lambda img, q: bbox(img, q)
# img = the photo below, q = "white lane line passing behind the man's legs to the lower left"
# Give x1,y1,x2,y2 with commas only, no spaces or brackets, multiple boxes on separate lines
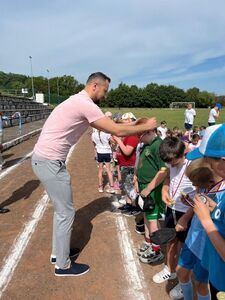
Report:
0,146,75,298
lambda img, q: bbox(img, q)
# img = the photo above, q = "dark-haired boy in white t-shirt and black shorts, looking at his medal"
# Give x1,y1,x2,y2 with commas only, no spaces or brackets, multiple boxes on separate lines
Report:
153,137,195,283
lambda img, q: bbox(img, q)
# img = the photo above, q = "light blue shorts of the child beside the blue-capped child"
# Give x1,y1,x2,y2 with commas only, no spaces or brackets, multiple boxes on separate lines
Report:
178,243,209,283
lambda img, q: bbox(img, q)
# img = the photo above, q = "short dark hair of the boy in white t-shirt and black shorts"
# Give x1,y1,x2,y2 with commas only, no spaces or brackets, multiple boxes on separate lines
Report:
159,137,185,163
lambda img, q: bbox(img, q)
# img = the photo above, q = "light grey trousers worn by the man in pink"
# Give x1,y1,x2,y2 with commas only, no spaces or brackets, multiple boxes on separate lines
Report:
32,154,75,269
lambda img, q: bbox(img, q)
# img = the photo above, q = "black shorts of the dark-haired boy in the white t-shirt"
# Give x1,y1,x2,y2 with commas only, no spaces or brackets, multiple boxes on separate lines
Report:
165,207,191,243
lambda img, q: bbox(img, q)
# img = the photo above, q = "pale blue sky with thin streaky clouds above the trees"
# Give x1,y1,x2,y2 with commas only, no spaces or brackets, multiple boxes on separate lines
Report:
0,0,225,95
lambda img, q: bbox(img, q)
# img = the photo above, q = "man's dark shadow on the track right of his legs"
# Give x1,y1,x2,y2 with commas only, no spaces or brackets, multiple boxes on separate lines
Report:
71,197,111,250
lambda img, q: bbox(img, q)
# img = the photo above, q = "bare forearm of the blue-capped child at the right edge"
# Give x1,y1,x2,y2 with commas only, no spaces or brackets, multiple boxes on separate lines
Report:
194,196,225,262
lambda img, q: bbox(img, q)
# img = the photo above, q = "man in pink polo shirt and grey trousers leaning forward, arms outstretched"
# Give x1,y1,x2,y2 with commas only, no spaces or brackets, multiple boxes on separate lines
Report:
32,72,156,276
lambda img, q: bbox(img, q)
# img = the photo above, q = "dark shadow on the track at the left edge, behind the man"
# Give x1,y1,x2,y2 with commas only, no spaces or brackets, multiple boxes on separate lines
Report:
0,180,40,207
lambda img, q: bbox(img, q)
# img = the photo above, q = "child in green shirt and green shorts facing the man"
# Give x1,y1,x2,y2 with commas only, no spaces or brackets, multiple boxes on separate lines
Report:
135,123,167,263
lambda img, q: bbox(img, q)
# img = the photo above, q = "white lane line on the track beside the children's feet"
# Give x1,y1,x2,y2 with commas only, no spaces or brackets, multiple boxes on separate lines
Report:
115,216,151,300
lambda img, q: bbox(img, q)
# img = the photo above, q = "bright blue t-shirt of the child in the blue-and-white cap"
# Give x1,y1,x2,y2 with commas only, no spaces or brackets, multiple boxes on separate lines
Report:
201,192,225,292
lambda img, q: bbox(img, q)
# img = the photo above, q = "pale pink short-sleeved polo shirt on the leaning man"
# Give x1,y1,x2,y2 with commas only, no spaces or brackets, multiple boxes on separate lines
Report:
34,90,105,160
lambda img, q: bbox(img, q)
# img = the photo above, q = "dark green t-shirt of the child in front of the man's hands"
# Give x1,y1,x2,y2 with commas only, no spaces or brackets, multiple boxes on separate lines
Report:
136,137,165,184
